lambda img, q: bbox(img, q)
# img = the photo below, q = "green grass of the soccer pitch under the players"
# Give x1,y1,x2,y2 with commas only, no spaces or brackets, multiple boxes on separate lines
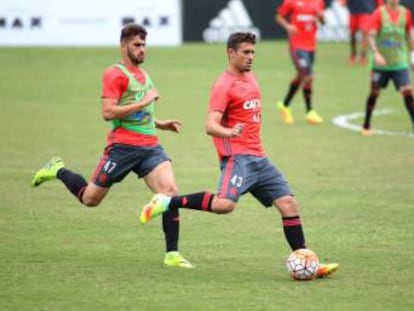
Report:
0,42,414,311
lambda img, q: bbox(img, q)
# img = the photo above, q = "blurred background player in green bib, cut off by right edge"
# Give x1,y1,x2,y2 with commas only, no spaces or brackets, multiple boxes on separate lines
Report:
362,0,414,136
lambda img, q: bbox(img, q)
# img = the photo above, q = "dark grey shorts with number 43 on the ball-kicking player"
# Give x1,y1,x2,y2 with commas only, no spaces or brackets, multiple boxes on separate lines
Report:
217,155,292,207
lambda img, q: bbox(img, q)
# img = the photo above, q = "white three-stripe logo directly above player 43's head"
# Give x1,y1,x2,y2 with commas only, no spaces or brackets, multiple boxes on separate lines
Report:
203,0,260,42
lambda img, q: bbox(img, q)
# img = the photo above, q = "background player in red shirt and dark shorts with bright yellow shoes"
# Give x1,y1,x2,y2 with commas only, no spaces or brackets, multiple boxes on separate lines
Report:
276,0,324,124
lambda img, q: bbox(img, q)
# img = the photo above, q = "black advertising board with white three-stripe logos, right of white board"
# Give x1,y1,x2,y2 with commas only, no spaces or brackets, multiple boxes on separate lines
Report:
183,0,414,42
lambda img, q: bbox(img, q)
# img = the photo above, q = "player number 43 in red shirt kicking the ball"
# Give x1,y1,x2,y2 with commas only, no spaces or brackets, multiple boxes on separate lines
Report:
140,32,338,277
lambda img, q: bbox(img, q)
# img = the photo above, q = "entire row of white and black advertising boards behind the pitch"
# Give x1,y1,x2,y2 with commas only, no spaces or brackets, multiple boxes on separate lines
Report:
0,0,414,46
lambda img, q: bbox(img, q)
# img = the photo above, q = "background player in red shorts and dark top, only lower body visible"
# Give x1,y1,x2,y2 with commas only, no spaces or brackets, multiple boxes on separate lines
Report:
340,0,383,64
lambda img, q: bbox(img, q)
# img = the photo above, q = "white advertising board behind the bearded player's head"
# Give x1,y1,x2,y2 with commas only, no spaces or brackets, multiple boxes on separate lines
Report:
0,0,182,46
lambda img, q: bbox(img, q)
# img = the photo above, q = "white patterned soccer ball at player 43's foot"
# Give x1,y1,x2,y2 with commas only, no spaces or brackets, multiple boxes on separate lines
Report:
286,248,319,280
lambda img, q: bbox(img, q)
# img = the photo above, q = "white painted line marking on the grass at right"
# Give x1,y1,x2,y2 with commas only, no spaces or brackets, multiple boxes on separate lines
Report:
332,109,414,138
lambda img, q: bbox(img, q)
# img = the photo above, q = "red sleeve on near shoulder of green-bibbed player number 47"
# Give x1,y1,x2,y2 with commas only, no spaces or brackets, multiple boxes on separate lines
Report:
102,67,128,98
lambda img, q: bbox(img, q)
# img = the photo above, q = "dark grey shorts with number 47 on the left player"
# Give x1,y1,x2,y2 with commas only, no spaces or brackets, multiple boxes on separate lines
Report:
91,144,170,188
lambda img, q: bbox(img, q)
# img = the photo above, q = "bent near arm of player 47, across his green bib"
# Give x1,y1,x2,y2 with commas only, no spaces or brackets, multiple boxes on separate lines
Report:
102,89,160,121
